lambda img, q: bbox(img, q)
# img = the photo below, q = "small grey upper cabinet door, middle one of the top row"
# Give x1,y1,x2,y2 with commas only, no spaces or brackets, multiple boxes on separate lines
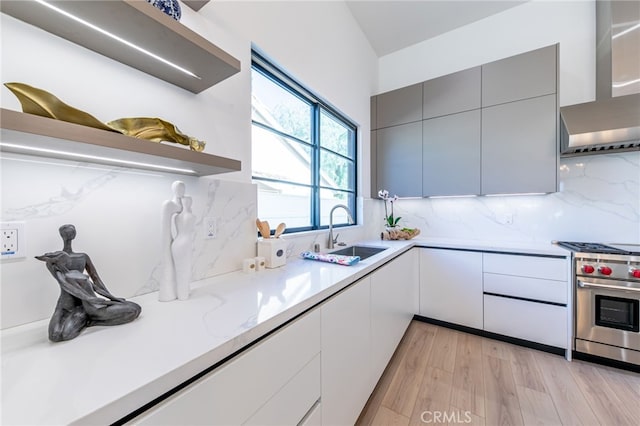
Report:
422,67,481,118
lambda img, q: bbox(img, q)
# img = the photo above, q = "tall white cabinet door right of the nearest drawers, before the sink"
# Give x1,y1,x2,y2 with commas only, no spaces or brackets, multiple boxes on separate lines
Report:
321,277,372,425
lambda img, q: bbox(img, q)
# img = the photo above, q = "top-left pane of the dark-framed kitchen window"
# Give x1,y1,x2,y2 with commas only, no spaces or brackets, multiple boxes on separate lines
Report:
251,70,312,142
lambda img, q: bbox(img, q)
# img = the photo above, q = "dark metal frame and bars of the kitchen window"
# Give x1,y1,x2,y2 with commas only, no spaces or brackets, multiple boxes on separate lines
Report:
251,49,358,233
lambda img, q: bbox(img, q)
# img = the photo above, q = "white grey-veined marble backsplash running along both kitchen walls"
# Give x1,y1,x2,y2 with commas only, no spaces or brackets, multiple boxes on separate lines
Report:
0,152,640,329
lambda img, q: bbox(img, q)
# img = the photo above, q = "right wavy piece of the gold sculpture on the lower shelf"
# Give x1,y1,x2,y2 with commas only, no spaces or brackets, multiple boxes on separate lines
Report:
107,117,205,152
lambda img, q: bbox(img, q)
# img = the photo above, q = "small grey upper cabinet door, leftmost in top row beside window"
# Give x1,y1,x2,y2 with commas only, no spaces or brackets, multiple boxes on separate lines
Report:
376,83,422,129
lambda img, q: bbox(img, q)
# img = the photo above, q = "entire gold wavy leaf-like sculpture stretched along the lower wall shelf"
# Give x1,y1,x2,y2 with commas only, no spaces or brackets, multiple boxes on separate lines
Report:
4,83,206,152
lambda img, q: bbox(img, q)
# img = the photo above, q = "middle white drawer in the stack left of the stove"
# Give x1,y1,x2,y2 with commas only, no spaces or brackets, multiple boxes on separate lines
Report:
483,272,567,305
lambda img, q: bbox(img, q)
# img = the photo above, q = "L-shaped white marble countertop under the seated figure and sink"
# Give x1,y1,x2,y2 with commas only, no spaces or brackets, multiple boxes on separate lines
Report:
1,239,568,425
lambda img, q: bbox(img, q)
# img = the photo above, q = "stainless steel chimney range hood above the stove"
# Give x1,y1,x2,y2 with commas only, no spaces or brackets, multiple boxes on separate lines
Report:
560,1,640,156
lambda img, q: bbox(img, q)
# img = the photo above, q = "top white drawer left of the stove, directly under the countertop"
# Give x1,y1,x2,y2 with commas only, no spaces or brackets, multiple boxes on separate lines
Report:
482,253,568,281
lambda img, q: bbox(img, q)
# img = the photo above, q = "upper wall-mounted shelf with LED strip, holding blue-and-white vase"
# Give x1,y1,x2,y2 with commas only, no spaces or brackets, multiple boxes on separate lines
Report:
0,0,240,93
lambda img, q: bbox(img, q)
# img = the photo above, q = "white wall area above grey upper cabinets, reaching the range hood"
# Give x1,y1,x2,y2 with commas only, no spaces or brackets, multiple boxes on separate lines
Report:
377,0,595,106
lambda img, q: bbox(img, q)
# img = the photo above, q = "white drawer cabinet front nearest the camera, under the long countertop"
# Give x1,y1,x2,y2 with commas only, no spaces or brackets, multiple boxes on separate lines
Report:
131,310,320,425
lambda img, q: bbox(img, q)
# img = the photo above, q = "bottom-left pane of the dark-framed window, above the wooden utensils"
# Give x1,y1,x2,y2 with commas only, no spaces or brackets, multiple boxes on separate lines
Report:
254,180,311,228
